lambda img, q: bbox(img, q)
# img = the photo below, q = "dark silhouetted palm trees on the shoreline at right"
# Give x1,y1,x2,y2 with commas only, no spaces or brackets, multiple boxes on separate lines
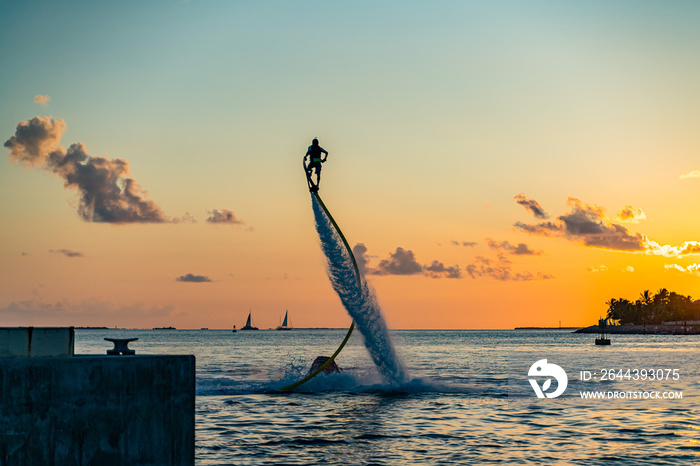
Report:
605,288,700,325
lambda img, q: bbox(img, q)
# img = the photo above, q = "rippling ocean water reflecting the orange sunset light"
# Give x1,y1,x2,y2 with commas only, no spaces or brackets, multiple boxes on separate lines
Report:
76,330,700,465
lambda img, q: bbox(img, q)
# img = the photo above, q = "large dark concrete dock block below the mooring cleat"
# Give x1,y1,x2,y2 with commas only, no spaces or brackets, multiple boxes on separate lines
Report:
0,355,195,466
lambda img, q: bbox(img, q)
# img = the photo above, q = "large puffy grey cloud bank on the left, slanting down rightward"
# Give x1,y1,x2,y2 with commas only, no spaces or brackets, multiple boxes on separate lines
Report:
5,117,169,223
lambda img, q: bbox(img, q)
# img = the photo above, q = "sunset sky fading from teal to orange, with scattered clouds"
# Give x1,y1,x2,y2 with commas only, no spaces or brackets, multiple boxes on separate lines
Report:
0,0,700,329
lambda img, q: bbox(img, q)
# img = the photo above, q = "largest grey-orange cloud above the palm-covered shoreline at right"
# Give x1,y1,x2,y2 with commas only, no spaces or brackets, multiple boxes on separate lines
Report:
514,197,646,251
